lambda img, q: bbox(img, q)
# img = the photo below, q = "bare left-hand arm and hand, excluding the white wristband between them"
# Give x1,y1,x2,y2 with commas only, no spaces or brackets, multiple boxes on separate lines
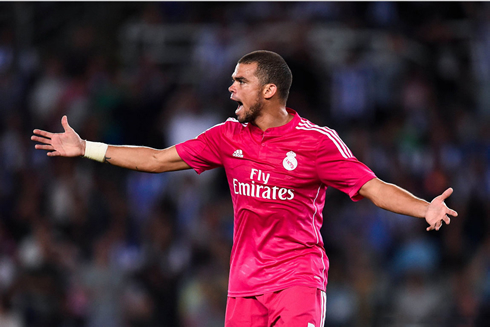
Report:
31,116,191,173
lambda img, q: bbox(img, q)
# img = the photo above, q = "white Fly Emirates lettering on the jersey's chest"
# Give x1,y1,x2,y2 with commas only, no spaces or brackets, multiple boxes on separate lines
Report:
233,168,294,201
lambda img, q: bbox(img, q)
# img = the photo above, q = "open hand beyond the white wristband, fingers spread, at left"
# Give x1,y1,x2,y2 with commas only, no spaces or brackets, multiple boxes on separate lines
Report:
31,115,85,157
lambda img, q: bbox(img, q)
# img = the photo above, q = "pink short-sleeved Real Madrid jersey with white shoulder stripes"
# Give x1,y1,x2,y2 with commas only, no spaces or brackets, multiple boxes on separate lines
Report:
176,109,376,297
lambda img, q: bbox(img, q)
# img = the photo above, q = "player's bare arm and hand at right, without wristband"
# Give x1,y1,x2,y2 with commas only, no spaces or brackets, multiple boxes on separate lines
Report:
359,178,458,231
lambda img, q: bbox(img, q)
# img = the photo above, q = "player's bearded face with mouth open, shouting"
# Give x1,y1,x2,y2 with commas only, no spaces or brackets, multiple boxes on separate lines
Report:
228,63,264,123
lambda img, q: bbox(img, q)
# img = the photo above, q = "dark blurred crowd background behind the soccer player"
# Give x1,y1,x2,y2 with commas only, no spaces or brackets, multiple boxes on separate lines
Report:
0,2,490,327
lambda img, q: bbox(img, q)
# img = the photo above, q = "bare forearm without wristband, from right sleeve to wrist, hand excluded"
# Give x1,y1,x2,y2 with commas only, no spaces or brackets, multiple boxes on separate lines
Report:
360,179,429,218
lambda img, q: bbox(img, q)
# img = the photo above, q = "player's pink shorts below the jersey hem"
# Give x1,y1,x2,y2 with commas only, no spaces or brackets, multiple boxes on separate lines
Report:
225,286,327,327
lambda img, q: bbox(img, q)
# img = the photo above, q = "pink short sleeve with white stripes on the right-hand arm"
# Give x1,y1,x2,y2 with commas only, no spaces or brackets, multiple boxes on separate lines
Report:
316,132,376,201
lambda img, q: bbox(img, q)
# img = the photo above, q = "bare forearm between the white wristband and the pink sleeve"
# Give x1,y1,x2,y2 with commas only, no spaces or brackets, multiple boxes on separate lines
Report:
82,145,190,173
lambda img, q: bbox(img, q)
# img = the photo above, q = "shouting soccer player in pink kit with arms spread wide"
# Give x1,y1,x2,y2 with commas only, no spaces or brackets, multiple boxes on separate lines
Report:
32,50,457,327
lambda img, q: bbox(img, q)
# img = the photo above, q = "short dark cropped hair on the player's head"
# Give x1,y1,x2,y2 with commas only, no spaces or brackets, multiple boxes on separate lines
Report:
238,50,293,102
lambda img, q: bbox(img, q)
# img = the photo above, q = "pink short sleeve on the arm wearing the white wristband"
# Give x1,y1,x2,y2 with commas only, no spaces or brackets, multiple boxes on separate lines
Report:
175,123,224,174
